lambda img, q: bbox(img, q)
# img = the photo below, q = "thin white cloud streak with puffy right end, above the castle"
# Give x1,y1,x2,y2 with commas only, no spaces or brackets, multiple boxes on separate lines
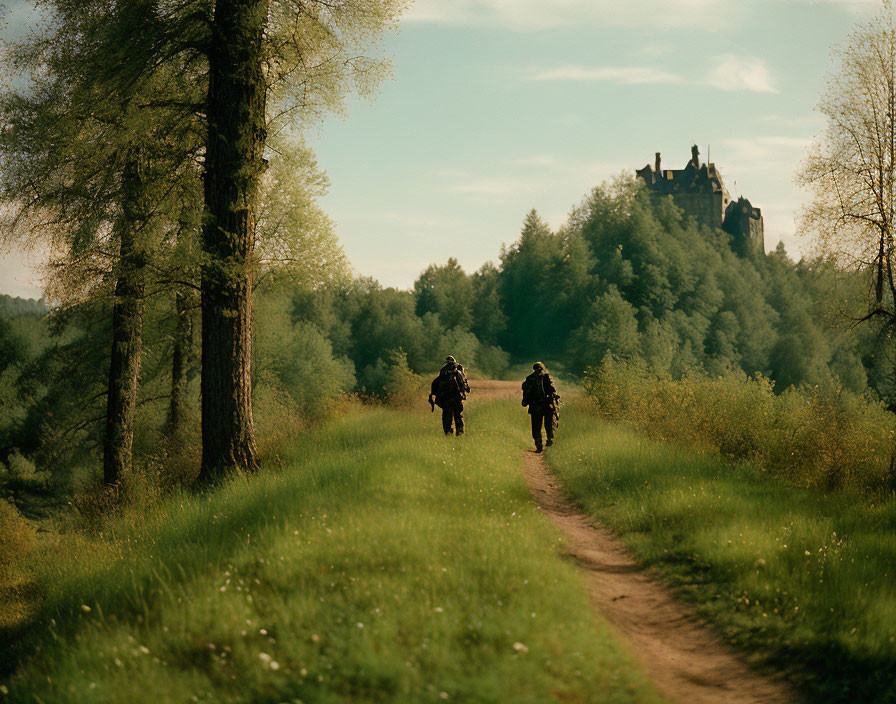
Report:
525,54,779,93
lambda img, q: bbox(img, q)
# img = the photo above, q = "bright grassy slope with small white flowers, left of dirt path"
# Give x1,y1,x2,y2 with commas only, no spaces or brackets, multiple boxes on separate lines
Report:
0,403,657,704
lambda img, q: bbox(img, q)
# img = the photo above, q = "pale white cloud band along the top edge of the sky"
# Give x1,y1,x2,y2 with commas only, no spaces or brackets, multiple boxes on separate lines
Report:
405,0,744,31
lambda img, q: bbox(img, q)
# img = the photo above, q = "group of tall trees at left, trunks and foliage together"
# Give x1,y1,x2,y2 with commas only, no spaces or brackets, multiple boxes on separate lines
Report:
0,0,407,493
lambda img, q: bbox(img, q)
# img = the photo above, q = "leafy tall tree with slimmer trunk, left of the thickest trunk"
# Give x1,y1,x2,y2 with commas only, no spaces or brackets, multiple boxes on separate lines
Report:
0,0,206,484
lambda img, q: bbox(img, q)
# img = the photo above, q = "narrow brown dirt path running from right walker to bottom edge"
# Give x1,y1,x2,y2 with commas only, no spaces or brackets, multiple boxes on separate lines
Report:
524,451,798,704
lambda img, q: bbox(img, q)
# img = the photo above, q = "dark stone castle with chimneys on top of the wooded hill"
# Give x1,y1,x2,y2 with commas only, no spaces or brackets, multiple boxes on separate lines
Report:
636,145,765,255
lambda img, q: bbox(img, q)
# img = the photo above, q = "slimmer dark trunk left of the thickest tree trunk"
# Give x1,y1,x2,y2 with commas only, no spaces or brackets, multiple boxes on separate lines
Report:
103,160,146,485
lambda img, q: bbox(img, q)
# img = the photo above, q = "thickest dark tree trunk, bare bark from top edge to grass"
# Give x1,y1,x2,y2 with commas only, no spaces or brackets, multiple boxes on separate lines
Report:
199,0,268,482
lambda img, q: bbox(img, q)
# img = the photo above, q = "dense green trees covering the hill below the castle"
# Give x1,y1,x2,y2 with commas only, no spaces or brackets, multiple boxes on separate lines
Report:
398,178,876,398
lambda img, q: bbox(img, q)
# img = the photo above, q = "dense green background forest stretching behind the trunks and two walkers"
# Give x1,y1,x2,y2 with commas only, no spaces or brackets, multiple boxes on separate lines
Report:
0,172,893,494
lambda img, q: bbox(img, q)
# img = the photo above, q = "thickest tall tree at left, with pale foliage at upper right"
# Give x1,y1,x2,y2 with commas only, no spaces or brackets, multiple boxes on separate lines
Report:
200,0,407,482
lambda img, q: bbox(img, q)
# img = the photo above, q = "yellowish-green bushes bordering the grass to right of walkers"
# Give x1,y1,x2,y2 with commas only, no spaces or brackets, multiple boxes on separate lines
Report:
584,355,896,491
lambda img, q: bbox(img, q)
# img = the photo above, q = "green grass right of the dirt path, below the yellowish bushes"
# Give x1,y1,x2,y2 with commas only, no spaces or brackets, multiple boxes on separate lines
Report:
548,404,896,704
